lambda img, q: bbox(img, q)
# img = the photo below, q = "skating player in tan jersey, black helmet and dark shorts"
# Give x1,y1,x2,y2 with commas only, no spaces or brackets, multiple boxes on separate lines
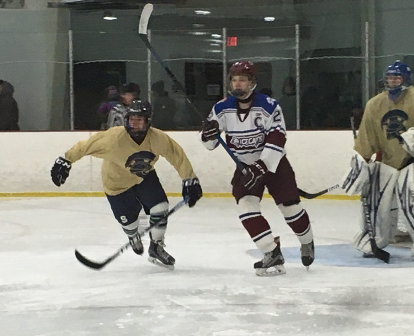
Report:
51,100,202,269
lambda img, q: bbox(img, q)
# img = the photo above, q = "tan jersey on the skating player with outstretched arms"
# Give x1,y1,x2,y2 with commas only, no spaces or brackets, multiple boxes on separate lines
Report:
65,126,195,195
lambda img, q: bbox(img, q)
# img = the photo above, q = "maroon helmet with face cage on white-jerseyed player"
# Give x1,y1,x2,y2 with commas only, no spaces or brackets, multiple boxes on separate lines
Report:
227,61,257,99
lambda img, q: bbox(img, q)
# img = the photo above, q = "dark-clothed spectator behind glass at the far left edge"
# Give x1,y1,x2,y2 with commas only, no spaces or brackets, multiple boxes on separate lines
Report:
0,79,20,131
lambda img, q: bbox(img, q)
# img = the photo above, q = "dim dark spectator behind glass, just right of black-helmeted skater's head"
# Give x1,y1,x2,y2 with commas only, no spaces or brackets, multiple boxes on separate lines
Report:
151,80,177,130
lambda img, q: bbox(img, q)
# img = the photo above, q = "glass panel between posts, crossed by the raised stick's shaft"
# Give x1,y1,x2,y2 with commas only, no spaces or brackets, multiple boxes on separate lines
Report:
151,27,223,130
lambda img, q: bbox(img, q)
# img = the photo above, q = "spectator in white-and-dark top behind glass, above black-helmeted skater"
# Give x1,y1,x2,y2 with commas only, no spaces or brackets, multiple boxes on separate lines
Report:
107,83,141,128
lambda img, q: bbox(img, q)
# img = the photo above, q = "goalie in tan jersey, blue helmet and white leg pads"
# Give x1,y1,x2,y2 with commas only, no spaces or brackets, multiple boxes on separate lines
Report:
343,61,414,256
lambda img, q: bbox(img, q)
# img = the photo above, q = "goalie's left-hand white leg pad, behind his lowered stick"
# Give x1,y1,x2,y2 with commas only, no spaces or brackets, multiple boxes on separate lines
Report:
353,162,399,253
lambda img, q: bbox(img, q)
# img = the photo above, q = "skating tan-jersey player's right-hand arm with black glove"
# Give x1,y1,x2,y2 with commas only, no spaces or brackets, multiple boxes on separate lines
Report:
157,131,203,208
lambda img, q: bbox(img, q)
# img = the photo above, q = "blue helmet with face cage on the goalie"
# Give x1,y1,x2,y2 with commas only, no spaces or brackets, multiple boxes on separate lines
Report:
384,61,411,100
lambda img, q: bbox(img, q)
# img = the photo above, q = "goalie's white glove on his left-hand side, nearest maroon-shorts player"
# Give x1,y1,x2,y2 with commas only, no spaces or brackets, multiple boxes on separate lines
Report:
342,151,369,196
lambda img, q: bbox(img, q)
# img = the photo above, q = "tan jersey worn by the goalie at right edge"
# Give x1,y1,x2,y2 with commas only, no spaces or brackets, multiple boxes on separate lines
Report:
354,86,414,169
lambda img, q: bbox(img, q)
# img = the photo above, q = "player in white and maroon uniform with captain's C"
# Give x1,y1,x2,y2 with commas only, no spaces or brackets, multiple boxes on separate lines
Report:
201,61,315,276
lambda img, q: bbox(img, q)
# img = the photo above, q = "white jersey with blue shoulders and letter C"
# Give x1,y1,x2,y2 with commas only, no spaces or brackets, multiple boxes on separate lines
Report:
200,93,286,173
